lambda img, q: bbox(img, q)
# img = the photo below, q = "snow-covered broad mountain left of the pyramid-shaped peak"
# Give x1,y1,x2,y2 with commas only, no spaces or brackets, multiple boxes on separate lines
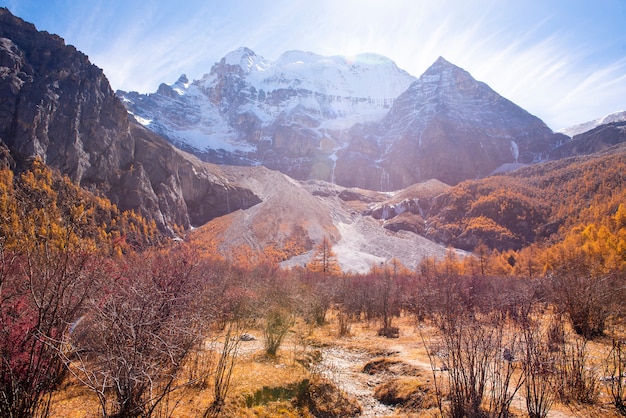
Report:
120,47,415,164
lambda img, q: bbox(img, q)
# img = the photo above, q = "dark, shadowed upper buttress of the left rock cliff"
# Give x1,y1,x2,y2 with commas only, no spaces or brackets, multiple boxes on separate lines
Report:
0,9,134,183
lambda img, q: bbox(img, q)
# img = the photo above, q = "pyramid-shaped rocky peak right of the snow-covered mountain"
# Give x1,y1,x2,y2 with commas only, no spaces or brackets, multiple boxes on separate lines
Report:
335,58,568,190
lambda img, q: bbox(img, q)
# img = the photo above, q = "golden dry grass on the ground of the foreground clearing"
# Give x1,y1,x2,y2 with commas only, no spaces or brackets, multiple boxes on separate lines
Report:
51,314,620,418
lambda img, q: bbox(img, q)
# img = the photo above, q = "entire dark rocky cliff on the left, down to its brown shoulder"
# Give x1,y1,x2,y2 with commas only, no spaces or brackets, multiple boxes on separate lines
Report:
0,9,260,230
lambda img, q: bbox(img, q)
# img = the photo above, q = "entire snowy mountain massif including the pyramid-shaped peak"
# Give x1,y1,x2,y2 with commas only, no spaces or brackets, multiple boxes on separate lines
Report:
118,48,569,190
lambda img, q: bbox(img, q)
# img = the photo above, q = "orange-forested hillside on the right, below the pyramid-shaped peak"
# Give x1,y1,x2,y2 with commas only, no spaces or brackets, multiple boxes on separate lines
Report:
416,143,626,250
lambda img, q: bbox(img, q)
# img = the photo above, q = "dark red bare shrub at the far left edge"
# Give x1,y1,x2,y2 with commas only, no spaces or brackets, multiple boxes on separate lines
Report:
0,239,106,418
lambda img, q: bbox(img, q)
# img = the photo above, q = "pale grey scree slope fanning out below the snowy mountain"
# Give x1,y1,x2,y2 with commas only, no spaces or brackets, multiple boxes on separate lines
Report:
186,172,447,273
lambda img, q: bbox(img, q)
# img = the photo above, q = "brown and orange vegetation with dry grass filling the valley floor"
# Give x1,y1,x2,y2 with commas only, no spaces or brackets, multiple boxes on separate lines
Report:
0,155,626,418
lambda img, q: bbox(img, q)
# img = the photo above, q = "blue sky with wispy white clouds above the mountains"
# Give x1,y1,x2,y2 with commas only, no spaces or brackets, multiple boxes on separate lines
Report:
0,0,626,130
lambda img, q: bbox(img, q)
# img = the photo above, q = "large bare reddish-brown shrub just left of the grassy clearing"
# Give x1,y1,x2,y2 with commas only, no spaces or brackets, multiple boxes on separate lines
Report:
67,249,203,418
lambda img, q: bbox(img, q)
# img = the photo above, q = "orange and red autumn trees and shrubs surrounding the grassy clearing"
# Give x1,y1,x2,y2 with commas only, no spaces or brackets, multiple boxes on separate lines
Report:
0,146,626,417
